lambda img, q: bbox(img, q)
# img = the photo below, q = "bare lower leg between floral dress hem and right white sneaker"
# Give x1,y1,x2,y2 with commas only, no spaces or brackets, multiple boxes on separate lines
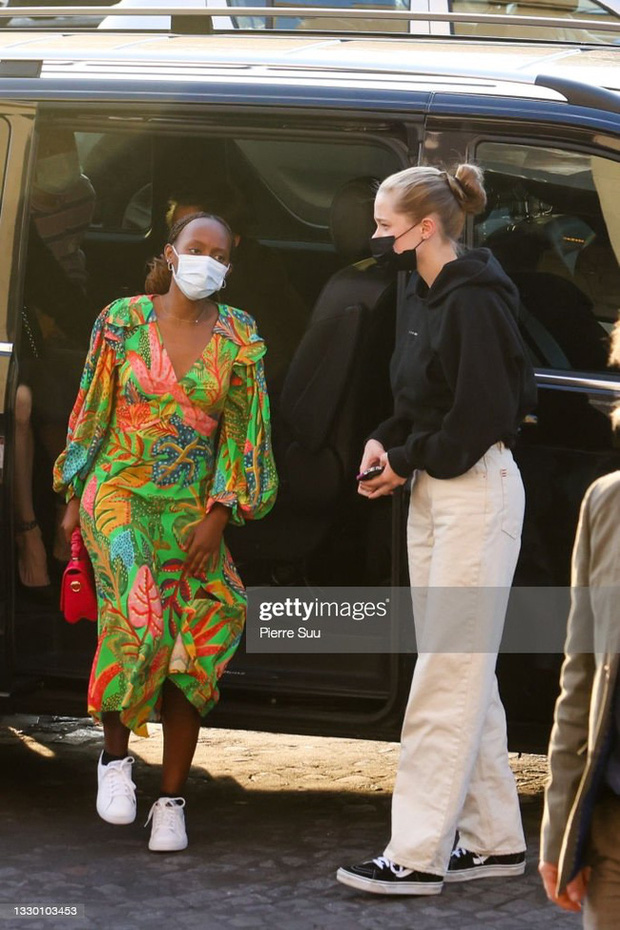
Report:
161,679,200,795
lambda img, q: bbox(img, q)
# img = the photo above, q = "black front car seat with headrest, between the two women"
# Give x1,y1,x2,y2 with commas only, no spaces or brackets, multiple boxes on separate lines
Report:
227,178,396,561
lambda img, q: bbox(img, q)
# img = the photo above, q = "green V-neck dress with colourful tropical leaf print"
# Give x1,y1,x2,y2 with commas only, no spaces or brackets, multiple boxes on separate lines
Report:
54,296,277,734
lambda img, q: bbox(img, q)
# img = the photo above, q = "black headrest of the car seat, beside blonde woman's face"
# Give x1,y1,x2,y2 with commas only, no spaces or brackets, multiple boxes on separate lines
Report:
329,177,379,262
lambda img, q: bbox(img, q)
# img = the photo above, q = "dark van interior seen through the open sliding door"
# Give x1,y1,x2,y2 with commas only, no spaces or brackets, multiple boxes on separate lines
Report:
15,114,403,724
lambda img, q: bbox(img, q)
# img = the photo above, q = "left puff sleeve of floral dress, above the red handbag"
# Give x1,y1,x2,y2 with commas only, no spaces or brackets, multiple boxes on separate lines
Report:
54,305,120,501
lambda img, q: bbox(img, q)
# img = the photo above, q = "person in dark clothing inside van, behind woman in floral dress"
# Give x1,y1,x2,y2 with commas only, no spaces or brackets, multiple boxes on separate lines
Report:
166,180,308,399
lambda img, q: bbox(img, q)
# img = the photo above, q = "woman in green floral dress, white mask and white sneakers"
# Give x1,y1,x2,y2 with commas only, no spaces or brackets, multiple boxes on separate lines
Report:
54,214,277,851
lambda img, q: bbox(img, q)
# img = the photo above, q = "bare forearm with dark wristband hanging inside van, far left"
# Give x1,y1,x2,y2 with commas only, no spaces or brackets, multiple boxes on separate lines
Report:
15,384,50,588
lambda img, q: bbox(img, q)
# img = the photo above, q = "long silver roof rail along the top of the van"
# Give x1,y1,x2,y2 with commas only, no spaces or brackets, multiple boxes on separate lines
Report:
0,5,620,38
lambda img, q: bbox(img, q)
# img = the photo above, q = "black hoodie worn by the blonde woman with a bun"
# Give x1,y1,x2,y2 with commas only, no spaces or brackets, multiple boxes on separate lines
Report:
371,249,536,478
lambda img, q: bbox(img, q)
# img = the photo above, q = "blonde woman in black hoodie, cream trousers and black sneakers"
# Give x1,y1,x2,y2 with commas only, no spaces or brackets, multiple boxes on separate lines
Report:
337,165,536,895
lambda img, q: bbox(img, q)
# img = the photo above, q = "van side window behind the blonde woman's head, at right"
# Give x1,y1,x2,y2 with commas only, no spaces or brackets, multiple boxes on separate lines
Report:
474,142,620,371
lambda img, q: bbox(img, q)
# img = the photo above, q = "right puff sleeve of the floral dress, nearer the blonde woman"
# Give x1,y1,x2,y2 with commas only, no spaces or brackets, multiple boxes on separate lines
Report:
206,314,278,525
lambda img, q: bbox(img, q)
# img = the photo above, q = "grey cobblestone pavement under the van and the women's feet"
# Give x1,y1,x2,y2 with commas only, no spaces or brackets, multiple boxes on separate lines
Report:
0,717,581,930
